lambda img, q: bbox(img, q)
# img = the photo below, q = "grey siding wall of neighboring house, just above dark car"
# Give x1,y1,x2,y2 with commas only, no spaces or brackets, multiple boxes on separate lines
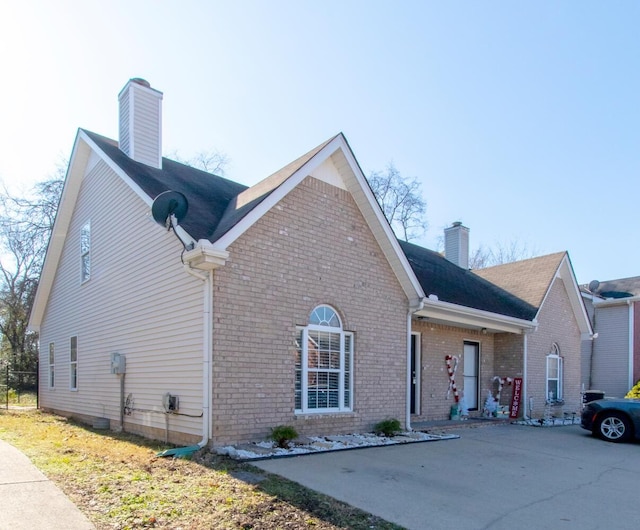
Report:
592,304,629,397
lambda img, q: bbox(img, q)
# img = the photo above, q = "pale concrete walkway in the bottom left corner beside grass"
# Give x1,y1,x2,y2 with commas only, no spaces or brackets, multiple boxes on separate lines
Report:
0,440,95,530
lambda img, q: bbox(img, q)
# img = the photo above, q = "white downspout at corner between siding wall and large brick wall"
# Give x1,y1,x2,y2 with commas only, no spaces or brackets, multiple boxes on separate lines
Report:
185,265,213,448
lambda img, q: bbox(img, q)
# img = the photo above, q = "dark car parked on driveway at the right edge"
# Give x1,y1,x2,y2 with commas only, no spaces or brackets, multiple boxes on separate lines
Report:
581,399,640,442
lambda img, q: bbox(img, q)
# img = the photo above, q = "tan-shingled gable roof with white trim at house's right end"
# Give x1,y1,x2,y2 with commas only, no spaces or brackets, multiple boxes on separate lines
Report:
473,252,593,335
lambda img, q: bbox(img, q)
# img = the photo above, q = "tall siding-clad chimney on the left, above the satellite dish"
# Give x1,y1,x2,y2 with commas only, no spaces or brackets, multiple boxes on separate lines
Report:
118,78,162,169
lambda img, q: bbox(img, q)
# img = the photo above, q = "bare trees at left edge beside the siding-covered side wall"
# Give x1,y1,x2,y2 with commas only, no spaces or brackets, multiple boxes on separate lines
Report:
0,163,66,371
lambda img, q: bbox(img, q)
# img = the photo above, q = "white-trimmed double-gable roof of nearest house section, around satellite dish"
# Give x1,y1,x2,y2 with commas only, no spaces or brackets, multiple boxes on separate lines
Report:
29,129,424,331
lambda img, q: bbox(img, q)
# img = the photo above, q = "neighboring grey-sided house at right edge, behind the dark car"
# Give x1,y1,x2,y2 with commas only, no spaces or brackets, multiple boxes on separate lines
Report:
581,276,640,397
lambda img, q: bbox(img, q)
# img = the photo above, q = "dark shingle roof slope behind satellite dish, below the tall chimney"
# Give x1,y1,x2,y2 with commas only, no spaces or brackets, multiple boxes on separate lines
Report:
84,130,247,240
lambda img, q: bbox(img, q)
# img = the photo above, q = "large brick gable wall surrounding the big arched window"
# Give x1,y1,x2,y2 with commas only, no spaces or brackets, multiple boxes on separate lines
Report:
213,177,408,445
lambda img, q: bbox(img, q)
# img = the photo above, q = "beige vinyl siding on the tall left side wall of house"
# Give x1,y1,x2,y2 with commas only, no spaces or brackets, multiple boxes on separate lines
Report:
40,158,203,439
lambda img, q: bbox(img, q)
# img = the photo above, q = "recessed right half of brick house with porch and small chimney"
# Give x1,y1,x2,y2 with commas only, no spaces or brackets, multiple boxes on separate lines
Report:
402,229,591,422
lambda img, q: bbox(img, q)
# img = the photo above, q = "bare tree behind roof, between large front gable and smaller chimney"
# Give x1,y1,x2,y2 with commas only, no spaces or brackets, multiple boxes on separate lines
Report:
368,162,427,241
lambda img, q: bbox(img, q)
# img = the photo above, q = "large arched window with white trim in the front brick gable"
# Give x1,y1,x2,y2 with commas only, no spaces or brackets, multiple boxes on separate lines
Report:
295,305,353,413
